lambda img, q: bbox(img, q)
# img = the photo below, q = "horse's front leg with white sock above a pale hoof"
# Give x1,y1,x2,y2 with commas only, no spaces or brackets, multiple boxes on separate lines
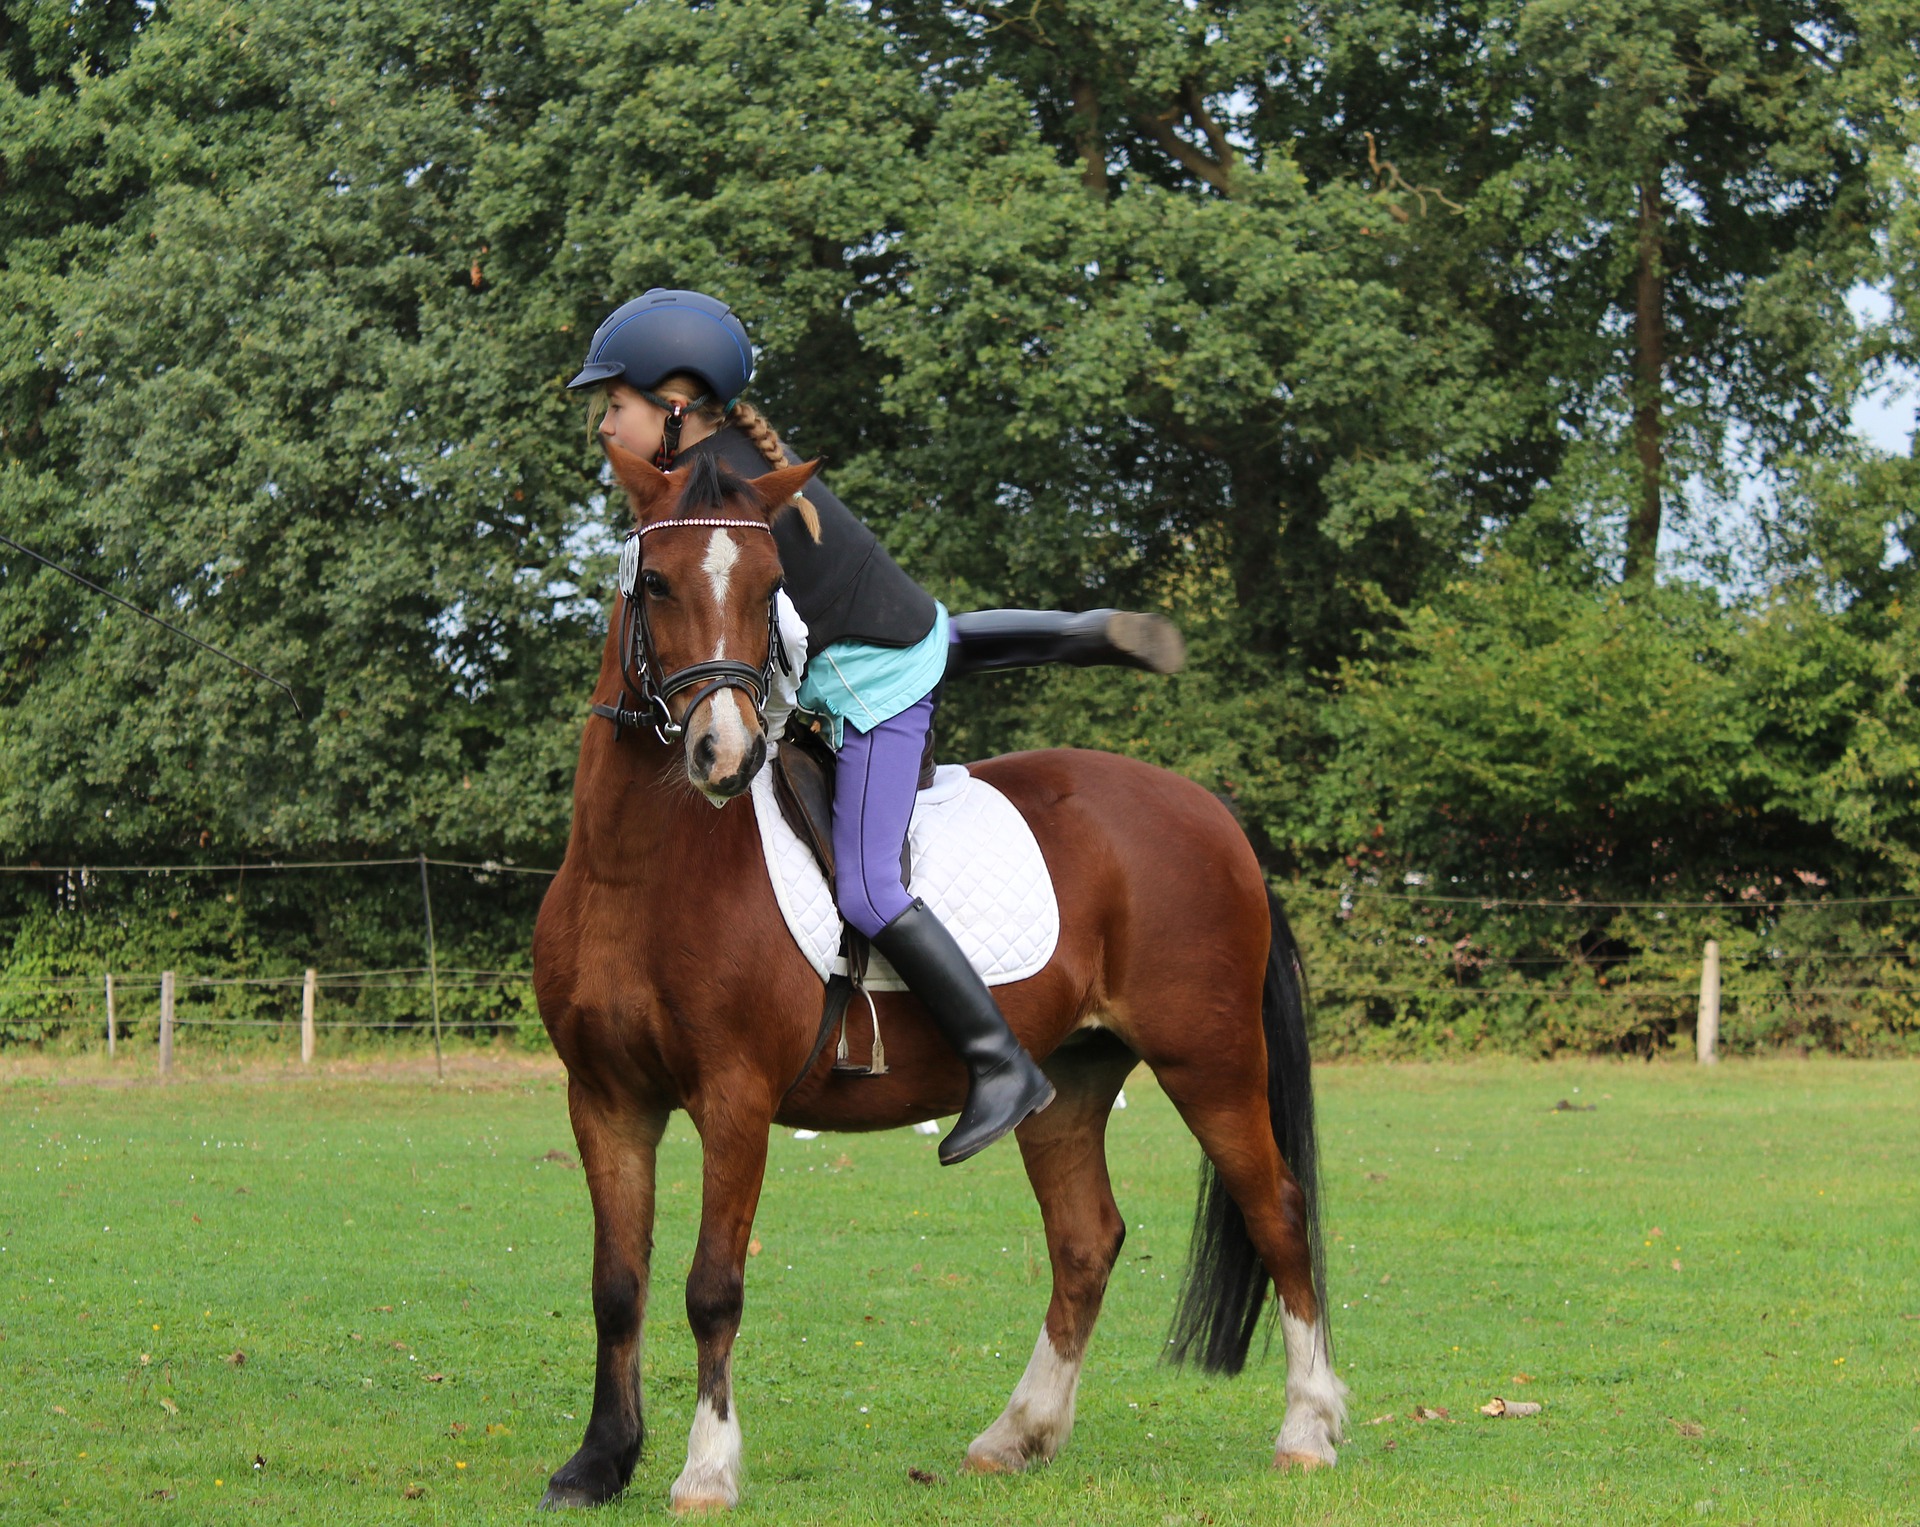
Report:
668,1108,772,1512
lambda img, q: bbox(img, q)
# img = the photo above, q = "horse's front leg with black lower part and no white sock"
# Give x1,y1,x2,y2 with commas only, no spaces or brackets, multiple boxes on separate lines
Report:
540,1085,666,1510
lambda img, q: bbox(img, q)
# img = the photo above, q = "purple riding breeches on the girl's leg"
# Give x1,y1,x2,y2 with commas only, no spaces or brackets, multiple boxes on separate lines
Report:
833,695,933,937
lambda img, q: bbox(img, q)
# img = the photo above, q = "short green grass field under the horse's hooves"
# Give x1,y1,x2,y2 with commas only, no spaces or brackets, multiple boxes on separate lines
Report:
0,1060,1920,1527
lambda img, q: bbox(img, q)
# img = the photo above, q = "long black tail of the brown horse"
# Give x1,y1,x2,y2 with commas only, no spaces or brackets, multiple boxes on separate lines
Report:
1167,891,1327,1373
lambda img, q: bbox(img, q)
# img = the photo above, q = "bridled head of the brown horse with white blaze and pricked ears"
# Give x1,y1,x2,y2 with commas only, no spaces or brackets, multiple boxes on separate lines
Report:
607,442,820,805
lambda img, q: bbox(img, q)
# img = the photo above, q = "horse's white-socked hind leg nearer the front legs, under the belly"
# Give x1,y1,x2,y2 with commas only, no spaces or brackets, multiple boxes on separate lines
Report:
966,1033,1139,1473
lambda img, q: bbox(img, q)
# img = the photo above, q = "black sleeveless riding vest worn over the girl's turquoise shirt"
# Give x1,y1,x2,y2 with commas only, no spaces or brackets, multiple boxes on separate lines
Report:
680,424,935,653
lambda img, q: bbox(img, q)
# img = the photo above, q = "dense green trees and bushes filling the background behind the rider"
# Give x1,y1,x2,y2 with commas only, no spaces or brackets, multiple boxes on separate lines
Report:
0,0,1920,1043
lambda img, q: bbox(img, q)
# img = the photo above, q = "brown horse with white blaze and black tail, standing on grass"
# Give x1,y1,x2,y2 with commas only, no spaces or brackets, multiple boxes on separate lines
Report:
534,449,1346,1510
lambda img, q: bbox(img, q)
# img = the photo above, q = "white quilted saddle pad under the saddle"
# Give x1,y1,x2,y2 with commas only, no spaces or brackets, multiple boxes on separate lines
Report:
751,764,1060,991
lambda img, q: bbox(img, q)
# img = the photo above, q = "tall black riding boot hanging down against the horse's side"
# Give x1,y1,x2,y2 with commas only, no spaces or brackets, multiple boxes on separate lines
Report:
874,897,1054,1166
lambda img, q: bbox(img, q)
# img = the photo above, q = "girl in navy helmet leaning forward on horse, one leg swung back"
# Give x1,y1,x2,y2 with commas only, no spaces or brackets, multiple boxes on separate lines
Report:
566,288,1185,1166
